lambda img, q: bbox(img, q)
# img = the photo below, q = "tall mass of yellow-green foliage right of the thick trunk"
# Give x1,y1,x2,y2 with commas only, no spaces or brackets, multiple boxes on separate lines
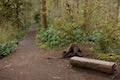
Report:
35,0,120,56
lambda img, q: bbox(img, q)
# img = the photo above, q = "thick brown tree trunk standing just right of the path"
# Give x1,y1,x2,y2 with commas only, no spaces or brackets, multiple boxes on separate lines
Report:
40,0,47,28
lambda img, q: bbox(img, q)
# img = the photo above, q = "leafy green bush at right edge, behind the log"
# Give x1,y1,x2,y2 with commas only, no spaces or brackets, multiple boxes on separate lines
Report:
90,28,120,53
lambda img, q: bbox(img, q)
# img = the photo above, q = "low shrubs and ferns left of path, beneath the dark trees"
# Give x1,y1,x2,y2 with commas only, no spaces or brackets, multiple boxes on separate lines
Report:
0,23,27,57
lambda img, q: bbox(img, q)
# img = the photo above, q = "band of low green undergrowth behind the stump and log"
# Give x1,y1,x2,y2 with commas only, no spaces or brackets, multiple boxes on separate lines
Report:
36,26,120,61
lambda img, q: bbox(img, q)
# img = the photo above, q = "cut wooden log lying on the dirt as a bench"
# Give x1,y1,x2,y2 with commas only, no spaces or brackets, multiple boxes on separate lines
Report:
70,57,117,74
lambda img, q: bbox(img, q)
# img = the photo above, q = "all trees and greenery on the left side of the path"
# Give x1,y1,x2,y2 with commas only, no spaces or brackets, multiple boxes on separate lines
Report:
0,0,31,56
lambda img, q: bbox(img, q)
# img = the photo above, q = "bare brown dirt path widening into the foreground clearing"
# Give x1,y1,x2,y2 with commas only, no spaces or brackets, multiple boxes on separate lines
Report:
0,26,115,80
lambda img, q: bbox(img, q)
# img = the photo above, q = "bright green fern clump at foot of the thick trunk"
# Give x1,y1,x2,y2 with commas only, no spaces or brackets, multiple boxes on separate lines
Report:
37,27,61,48
